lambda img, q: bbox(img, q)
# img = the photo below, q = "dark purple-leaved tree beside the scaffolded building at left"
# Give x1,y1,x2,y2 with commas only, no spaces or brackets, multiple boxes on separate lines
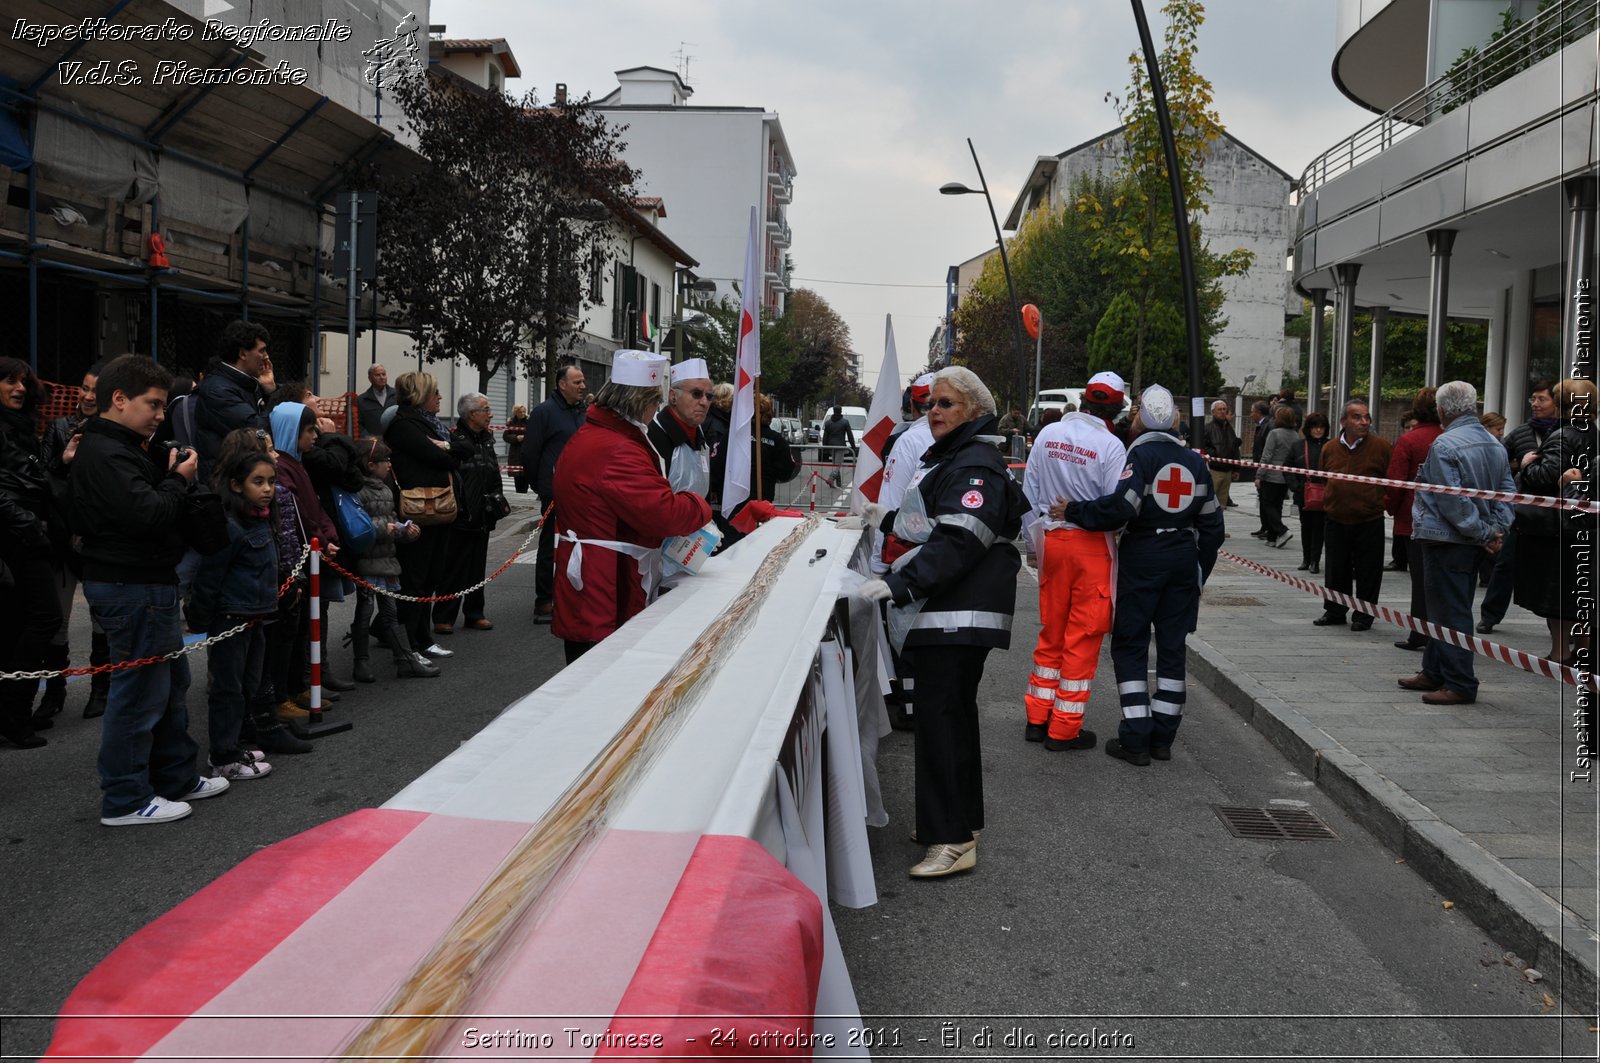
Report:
373,75,635,387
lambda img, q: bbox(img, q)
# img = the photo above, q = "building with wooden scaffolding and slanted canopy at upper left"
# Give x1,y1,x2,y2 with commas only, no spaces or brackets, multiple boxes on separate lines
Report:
0,0,429,381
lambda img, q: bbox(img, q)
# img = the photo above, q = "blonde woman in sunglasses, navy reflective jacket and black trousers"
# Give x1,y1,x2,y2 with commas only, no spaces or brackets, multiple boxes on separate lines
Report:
859,367,1027,879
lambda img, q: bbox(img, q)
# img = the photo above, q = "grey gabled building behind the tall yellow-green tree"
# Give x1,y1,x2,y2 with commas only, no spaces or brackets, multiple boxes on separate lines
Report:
1005,126,1299,387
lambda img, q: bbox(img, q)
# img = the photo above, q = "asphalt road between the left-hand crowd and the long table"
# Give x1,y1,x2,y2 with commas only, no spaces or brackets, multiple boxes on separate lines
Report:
0,514,563,1058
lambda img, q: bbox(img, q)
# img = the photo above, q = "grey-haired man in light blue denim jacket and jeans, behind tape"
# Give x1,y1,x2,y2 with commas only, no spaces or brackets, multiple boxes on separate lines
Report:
1400,379,1517,704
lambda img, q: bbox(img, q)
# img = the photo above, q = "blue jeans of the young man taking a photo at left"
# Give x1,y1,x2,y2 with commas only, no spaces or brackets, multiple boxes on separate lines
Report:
83,580,200,816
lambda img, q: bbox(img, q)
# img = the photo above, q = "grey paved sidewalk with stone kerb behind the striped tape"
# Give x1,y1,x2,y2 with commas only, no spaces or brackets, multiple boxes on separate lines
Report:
1189,483,1600,1010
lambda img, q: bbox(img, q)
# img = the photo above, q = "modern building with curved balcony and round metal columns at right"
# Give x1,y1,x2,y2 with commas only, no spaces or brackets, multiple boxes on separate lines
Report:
1291,0,1600,424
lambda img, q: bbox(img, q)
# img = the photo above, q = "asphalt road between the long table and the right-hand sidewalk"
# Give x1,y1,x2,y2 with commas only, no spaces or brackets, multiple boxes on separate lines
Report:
832,573,1595,1060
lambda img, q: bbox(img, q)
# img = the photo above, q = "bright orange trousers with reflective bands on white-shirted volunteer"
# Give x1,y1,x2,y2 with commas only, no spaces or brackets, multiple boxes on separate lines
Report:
1024,528,1112,740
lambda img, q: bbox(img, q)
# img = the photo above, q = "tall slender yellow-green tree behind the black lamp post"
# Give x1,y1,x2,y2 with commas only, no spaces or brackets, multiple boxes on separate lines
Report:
1078,0,1253,391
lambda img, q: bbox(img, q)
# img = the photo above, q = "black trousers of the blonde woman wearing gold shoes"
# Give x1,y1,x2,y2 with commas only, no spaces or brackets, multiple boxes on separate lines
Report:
901,645,989,845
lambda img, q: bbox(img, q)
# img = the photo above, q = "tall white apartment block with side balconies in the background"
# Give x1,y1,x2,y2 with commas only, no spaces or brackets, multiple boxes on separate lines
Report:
595,66,795,314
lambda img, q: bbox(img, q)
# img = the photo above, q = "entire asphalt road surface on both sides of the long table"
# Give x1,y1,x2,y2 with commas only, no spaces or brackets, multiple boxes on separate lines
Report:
0,530,1594,1058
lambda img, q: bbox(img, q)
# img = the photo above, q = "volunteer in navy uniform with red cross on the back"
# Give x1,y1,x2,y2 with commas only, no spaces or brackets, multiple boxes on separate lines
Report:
1066,384,1222,767
